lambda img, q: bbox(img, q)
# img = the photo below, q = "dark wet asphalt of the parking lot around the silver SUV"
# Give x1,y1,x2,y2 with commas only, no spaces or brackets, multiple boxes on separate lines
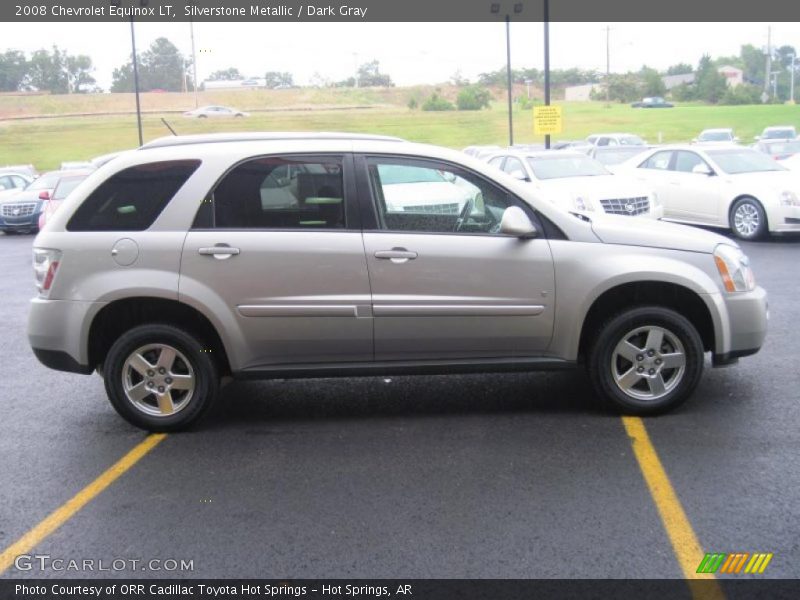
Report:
0,231,800,578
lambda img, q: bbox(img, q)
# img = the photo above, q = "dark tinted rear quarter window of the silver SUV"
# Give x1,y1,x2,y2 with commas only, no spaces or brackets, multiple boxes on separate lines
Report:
67,160,200,231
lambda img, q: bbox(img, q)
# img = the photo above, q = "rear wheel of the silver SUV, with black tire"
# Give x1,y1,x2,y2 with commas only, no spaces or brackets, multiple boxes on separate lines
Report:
103,324,219,432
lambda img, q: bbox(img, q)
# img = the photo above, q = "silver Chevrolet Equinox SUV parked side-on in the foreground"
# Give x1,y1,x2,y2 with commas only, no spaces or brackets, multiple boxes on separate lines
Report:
28,134,767,431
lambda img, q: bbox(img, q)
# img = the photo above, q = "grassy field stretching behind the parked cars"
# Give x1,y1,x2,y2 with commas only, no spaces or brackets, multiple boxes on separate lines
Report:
0,96,800,170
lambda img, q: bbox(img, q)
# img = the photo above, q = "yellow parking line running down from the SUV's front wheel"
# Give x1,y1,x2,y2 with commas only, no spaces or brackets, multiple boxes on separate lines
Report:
622,417,725,600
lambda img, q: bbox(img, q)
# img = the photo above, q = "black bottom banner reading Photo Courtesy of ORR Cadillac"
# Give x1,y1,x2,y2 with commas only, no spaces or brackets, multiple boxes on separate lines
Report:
0,577,800,600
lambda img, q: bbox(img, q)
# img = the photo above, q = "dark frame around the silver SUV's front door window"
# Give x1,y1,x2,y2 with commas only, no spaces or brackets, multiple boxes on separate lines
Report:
354,153,548,239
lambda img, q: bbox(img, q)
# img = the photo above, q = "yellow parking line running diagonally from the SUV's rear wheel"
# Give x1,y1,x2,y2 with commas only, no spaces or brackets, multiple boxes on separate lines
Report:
0,433,167,575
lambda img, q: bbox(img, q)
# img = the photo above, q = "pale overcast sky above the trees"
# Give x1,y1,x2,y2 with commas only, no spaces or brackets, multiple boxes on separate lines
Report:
0,22,800,89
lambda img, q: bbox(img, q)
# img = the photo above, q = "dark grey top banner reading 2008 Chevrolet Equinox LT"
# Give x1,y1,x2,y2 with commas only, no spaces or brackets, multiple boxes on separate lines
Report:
0,0,800,22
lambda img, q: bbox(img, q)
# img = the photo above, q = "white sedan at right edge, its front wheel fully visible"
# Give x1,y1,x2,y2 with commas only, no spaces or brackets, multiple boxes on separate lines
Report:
618,145,800,240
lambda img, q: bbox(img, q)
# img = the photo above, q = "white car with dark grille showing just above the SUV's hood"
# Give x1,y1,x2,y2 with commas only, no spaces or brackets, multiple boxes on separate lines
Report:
486,150,663,219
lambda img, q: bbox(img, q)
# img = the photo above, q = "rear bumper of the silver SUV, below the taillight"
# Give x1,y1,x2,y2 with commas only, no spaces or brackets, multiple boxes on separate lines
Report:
28,297,106,373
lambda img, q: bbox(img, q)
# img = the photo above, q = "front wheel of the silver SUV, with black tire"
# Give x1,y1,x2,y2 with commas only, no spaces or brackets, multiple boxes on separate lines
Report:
588,306,704,415
